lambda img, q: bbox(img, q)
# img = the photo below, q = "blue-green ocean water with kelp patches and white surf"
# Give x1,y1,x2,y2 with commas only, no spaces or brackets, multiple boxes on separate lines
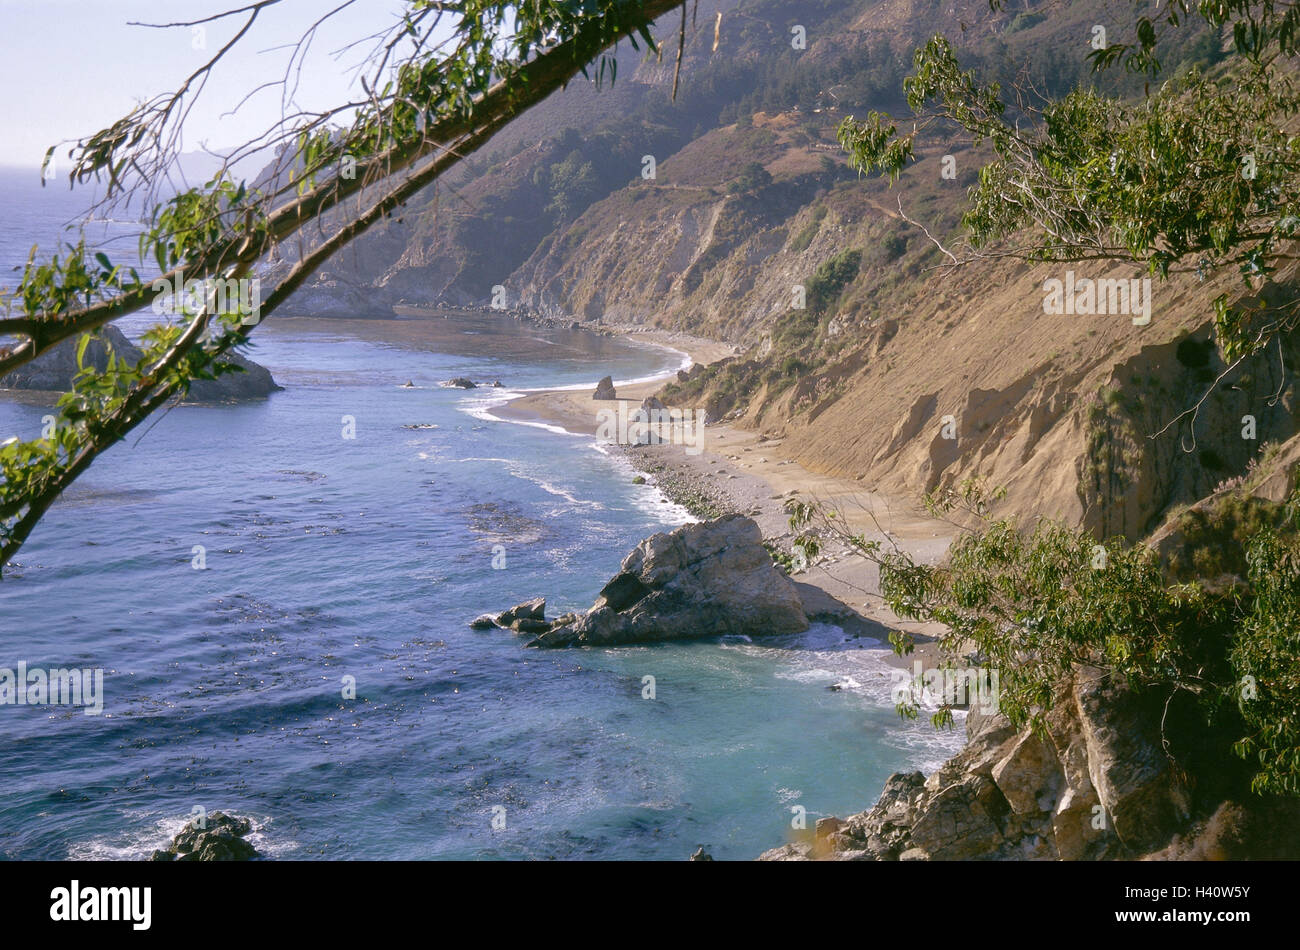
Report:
0,165,961,860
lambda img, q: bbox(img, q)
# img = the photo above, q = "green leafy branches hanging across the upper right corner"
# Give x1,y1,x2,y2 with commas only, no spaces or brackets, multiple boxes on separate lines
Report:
840,0,1300,361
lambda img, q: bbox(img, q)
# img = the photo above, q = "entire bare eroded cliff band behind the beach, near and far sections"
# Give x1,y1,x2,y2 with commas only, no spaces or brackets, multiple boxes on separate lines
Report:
511,125,1297,539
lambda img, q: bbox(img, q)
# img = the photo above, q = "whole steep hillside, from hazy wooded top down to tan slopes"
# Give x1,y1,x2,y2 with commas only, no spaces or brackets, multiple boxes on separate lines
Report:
276,0,1258,538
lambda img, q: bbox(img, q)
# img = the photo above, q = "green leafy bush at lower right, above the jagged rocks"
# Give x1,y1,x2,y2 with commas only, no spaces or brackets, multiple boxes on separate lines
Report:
788,481,1300,795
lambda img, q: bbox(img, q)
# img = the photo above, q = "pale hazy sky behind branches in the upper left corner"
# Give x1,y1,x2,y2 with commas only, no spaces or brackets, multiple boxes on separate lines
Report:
0,0,426,166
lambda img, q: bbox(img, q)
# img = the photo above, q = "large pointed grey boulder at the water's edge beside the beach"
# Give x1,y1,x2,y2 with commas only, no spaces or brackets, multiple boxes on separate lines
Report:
533,515,809,647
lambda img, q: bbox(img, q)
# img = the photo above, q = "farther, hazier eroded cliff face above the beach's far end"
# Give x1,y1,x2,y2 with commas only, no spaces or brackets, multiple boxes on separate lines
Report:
508,116,852,335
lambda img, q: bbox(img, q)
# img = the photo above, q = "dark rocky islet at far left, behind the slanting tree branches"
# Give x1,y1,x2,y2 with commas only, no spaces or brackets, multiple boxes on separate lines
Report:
0,325,283,403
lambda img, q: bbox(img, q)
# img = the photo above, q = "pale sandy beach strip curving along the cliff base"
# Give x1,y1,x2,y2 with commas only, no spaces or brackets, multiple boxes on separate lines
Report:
494,327,953,667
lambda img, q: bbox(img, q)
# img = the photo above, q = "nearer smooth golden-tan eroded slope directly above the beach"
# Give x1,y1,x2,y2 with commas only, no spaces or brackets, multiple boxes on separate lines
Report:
722,252,1297,541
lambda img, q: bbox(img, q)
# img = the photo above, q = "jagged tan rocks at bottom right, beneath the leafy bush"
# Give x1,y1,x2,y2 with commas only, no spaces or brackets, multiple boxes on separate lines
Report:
762,667,1190,860
